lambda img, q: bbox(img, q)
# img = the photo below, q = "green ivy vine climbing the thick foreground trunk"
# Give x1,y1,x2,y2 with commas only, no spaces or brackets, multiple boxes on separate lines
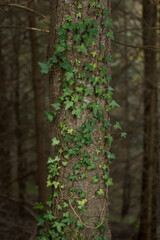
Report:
35,0,126,240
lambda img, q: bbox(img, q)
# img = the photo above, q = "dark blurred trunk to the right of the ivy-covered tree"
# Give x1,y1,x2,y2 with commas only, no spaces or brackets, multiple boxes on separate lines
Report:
138,0,157,240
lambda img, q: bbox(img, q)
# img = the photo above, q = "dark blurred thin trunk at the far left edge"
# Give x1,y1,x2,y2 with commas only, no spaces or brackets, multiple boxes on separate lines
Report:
0,32,11,195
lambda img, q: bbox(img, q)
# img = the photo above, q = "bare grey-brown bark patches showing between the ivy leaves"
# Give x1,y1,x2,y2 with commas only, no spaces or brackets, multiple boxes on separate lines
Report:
50,0,110,240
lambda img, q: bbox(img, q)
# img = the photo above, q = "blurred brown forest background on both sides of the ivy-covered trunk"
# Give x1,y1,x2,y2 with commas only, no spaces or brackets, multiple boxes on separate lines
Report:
0,0,160,240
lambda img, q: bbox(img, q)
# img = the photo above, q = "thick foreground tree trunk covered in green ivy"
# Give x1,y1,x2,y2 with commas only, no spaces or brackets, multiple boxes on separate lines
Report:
47,0,113,240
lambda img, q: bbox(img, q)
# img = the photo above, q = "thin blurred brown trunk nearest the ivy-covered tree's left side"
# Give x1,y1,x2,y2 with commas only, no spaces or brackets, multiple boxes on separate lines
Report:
28,1,47,202
